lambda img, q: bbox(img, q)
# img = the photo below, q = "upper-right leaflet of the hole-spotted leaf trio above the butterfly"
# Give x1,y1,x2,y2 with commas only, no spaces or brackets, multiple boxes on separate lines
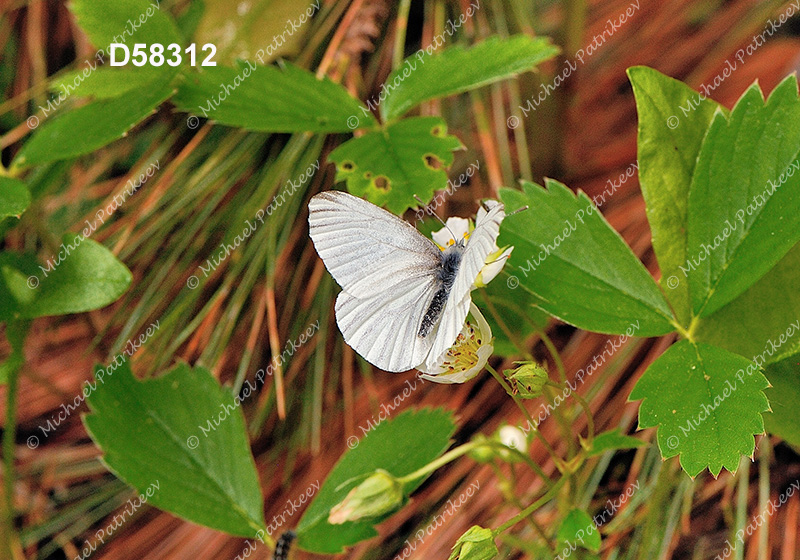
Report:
381,35,559,121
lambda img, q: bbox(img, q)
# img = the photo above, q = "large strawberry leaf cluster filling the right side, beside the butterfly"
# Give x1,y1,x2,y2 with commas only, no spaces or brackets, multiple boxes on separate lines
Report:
499,67,800,476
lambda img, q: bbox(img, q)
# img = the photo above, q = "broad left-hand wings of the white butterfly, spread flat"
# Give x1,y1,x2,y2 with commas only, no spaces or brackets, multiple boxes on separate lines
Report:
309,191,442,372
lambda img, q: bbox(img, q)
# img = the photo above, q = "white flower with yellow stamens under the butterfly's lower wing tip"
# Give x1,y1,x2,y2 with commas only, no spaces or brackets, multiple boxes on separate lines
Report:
417,303,494,383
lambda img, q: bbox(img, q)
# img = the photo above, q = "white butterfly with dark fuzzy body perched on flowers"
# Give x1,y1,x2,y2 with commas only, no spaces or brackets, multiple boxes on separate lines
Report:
308,191,505,372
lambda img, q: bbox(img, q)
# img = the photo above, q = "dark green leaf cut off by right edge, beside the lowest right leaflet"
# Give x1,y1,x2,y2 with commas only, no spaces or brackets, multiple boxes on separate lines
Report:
764,354,800,447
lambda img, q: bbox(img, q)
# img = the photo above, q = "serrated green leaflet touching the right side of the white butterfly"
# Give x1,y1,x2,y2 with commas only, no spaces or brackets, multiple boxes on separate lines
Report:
498,180,673,336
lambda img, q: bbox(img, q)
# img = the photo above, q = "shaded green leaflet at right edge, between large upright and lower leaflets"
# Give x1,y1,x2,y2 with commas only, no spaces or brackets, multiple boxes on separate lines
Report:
695,244,800,364
